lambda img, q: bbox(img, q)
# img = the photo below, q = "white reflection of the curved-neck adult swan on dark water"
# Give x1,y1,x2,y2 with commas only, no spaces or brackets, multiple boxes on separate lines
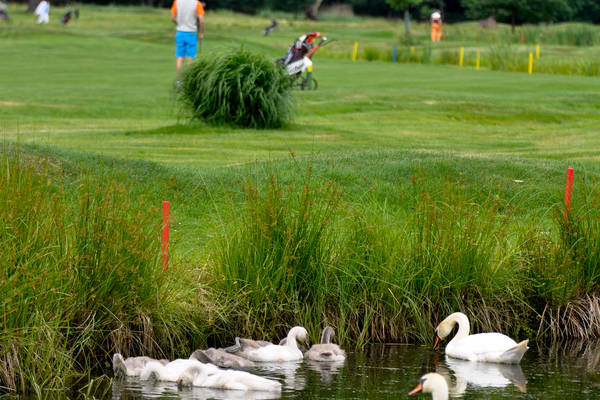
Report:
437,356,527,396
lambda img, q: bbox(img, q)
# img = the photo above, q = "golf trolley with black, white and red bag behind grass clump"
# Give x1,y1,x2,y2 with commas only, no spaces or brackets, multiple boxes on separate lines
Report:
276,32,335,90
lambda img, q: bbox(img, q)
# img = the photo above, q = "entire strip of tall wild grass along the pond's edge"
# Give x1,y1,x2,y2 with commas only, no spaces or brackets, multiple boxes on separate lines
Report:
0,145,600,392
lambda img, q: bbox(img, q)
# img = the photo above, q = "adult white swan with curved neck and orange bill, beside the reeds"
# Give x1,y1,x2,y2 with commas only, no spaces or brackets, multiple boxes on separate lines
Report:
433,312,529,364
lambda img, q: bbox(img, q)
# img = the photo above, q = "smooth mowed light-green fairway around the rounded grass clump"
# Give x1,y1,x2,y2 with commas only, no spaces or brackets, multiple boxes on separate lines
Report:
0,8,600,167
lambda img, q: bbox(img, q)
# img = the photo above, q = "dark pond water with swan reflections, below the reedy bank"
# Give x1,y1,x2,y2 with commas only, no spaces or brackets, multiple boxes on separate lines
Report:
109,342,600,400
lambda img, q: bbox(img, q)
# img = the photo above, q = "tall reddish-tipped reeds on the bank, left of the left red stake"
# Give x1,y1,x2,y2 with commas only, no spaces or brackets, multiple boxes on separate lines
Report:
0,149,204,395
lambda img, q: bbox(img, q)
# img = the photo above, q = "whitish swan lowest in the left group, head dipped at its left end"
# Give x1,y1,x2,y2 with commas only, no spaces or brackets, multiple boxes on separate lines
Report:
177,364,281,392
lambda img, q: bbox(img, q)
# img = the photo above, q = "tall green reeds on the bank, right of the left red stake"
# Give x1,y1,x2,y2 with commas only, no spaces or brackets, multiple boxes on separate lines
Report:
207,166,600,346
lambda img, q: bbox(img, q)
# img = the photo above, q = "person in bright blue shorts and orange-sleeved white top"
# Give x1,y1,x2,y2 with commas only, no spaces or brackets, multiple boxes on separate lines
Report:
171,0,204,84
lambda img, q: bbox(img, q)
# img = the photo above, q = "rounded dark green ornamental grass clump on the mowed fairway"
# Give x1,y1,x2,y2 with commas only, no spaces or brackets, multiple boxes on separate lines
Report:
180,48,293,128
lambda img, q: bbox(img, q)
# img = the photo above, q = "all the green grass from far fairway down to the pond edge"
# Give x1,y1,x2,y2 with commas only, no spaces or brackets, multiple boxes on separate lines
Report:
0,6,600,391
